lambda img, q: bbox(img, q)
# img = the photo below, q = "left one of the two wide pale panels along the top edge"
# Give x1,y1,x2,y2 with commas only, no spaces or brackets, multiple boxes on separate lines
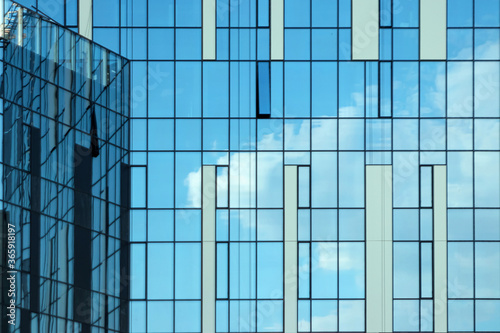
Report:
352,0,379,60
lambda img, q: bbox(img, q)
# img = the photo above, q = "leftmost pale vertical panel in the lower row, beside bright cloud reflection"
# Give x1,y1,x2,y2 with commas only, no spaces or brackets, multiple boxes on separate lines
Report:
201,165,216,333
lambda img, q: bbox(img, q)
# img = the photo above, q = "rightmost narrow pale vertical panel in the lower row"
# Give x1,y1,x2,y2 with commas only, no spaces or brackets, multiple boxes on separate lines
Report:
433,165,448,333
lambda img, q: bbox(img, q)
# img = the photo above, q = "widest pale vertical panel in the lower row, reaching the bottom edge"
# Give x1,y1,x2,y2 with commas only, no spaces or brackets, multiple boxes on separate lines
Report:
366,165,392,333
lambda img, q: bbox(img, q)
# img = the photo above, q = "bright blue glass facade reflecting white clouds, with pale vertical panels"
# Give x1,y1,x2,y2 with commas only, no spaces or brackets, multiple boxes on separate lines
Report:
0,0,500,333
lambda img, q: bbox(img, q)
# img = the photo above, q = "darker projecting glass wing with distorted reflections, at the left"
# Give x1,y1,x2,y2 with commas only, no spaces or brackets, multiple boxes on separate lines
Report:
0,4,130,333
